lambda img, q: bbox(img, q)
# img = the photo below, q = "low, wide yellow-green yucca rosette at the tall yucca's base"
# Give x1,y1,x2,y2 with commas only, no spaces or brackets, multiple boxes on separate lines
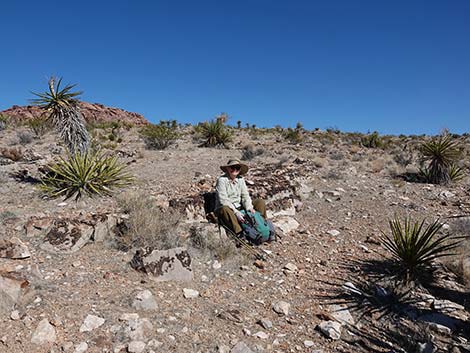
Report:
41,152,133,200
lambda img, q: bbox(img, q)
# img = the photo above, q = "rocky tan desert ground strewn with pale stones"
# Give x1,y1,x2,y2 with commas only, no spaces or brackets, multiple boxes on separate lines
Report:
0,119,470,353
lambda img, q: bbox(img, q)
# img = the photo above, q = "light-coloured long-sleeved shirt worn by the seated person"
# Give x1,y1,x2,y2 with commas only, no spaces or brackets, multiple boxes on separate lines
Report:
215,175,253,214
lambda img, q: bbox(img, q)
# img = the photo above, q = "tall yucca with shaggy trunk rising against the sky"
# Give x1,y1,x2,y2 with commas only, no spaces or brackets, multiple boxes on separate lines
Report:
32,77,90,155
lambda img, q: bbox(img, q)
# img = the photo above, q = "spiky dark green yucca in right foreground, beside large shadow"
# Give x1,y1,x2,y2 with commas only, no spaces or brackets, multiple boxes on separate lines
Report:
382,216,460,282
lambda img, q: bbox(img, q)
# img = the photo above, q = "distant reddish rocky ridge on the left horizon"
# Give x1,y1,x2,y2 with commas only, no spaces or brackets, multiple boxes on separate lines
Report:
0,102,149,125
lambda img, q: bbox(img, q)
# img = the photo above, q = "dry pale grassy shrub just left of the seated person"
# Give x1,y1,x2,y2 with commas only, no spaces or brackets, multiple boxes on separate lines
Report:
115,192,182,251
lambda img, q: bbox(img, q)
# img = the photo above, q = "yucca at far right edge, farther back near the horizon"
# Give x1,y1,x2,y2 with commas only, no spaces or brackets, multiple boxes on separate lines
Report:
421,134,463,184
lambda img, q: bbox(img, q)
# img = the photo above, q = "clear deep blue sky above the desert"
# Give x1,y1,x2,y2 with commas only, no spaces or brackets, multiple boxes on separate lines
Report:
0,0,470,134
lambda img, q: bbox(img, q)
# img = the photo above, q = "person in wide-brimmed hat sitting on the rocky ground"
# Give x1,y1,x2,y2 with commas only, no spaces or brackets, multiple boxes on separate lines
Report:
215,159,266,235
